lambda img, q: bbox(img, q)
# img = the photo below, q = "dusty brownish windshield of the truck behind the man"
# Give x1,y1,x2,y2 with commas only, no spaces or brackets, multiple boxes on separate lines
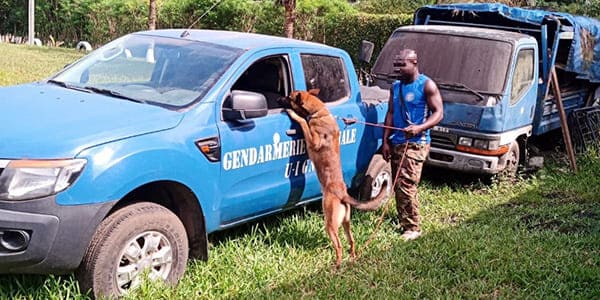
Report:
373,31,512,103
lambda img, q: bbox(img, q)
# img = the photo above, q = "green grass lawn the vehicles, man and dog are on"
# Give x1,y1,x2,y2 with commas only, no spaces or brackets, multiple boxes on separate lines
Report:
0,44,600,299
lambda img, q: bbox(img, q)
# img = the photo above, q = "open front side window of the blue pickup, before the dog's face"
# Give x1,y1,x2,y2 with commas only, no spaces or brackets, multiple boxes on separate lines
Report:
231,55,291,110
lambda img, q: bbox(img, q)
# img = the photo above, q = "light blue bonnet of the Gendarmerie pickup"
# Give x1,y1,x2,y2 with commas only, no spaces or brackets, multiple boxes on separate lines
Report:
0,83,183,159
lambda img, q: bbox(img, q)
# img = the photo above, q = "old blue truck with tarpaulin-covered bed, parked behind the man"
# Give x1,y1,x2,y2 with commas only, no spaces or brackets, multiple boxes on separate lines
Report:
372,4,600,175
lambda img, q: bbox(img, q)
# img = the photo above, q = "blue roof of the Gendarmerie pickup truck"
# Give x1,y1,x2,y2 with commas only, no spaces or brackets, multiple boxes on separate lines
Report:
133,29,336,49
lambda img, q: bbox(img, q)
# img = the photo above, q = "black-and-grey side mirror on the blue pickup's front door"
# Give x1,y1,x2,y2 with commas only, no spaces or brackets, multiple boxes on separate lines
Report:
223,90,268,121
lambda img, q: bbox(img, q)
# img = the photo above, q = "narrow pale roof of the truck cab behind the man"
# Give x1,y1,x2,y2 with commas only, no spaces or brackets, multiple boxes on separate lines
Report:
396,25,535,43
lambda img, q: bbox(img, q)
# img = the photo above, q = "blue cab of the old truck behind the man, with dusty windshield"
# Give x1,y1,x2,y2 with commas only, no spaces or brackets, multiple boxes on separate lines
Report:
374,25,538,173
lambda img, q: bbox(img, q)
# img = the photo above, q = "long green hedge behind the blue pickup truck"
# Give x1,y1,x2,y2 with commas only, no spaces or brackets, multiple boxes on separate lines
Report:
0,0,412,63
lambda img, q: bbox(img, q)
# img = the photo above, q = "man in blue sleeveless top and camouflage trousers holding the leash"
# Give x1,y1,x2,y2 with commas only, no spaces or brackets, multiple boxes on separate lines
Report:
382,49,443,241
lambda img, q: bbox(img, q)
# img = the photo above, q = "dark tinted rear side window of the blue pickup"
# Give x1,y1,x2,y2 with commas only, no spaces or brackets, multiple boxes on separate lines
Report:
301,54,350,102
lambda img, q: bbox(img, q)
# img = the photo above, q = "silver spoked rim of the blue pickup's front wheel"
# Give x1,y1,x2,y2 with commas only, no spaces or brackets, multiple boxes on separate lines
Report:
115,231,173,294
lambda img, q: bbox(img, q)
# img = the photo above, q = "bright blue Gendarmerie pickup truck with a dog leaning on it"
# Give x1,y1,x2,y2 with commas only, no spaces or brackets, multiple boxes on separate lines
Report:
0,30,391,295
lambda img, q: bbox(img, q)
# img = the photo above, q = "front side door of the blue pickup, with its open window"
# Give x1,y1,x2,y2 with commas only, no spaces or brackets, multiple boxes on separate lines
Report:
217,51,306,225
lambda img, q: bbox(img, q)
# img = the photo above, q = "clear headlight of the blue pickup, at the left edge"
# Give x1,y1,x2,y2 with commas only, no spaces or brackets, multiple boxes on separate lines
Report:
0,159,86,200
